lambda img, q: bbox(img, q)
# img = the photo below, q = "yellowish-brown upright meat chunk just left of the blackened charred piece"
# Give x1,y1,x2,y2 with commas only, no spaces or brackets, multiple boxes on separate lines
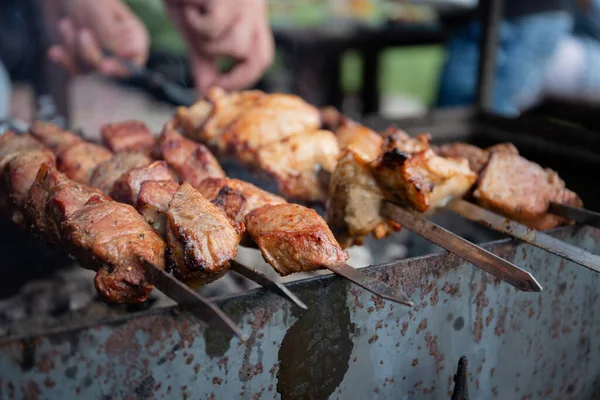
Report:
326,148,400,248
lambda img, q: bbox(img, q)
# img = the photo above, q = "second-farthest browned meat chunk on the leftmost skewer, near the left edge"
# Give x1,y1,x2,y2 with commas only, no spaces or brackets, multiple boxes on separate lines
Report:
3,149,54,225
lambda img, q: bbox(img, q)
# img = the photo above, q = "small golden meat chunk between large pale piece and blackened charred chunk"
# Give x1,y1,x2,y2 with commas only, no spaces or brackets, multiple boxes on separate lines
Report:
335,121,383,161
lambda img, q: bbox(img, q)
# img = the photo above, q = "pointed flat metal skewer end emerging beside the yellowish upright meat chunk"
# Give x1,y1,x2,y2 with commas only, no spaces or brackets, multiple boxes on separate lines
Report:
382,202,542,292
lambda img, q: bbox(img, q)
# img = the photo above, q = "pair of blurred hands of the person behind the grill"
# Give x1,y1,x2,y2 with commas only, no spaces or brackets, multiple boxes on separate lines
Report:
48,0,275,94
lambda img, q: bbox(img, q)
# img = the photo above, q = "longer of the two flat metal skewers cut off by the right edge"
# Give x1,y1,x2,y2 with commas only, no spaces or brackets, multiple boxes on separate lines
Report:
446,199,600,272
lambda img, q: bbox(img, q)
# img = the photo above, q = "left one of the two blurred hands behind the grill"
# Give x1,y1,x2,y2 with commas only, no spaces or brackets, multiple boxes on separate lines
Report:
48,0,150,77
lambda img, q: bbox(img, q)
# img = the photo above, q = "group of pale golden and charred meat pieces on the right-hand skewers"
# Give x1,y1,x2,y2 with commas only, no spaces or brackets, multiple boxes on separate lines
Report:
175,89,582,247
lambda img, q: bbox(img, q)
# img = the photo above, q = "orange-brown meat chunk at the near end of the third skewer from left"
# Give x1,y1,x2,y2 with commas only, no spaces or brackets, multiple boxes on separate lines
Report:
246,204,348,276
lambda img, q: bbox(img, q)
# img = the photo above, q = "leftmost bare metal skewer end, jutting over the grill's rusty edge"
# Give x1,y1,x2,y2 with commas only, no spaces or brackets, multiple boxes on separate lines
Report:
143,259,248,342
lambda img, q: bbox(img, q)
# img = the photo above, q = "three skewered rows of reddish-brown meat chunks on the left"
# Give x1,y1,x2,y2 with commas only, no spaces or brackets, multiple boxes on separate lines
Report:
0,123,347,302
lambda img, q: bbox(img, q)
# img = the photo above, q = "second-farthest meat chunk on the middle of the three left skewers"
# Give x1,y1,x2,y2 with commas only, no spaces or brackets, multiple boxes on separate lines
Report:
56,142,113,184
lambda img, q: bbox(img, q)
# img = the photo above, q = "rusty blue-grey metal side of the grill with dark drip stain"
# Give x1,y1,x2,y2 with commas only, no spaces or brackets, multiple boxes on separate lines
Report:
0,228,600,400
